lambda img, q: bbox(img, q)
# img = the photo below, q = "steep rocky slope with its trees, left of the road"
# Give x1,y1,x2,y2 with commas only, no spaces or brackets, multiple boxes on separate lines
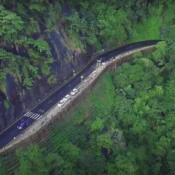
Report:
0,1,90,131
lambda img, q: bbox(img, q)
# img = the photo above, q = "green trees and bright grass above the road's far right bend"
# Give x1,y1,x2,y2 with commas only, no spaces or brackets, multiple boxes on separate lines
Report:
66,0,175,47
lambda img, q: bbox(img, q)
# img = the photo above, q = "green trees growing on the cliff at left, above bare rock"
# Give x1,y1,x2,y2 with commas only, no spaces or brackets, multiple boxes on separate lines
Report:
0,1,53,92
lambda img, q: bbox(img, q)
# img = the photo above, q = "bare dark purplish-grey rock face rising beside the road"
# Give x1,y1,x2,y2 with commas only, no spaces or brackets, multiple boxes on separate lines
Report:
0,25,91,132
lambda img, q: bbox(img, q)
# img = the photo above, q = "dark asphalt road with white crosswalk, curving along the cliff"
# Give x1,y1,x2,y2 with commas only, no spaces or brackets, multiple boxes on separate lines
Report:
0,40,161,149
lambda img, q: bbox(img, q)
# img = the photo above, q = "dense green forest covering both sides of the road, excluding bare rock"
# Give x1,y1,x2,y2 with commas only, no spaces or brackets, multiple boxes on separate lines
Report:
0,0,175,175
